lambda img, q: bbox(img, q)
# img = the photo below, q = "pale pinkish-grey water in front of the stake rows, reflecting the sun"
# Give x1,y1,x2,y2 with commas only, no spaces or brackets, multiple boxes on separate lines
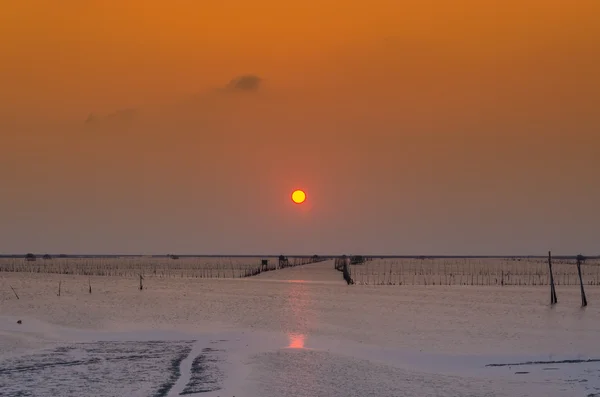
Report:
0,263,600,397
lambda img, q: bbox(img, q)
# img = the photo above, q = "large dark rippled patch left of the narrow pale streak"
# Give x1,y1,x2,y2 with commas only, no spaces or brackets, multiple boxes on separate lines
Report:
0,341,194,397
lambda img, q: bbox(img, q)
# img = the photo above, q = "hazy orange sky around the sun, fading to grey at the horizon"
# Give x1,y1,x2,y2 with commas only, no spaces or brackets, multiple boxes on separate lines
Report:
0,0,600,255
